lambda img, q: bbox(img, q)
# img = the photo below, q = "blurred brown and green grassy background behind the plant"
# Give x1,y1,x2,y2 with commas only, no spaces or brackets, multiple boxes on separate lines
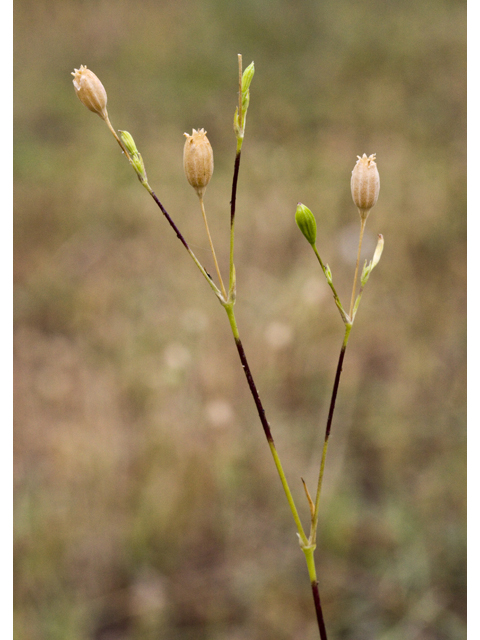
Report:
14,0,466,640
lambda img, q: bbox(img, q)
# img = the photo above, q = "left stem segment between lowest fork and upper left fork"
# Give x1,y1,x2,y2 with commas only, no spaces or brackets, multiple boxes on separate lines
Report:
224,304,308,545
